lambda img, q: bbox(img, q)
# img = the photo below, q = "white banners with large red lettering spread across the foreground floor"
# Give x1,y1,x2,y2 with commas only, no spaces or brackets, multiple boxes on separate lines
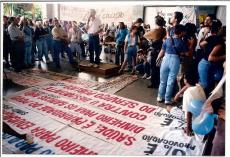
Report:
3,82,203,155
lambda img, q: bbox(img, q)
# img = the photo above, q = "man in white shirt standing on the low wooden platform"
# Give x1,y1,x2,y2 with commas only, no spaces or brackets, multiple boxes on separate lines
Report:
87,9,102,68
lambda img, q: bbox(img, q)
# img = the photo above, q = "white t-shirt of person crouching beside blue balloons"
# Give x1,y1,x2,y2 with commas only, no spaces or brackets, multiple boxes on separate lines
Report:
182,84,206,113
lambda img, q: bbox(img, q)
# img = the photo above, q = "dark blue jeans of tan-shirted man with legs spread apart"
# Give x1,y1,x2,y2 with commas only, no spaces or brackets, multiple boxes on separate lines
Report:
53,40,73,66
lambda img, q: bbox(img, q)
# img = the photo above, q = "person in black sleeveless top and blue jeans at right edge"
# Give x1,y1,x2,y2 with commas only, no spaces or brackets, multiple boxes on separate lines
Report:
198,22,226,95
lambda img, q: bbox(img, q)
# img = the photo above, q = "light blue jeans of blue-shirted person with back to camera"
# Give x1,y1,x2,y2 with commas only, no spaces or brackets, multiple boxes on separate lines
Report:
158,54,180,102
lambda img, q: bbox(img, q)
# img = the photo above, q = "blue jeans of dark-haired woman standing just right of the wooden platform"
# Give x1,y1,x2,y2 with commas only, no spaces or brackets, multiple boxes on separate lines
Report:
125,46,137,69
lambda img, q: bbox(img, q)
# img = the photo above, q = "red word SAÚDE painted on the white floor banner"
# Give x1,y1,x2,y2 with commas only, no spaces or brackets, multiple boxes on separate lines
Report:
95,124,136,146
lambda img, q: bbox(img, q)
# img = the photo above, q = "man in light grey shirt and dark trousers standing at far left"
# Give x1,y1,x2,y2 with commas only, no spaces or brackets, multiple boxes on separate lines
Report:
8,17,24,72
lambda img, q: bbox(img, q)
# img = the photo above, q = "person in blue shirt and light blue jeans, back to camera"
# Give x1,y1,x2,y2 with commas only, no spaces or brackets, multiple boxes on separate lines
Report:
157,25,188,104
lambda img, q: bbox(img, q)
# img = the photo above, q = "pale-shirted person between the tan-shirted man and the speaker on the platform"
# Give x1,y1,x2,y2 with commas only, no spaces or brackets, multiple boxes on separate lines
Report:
68,21,82,59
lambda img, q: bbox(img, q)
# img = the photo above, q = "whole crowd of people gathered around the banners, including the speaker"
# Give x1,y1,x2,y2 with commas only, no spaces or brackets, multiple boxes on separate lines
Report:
3,9,226,155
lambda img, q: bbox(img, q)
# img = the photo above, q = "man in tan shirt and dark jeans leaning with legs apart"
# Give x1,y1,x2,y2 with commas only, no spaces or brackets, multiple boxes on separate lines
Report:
52,19,74,68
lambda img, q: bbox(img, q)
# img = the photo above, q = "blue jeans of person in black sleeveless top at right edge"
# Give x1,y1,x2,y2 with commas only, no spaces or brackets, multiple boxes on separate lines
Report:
198,59,211,89
